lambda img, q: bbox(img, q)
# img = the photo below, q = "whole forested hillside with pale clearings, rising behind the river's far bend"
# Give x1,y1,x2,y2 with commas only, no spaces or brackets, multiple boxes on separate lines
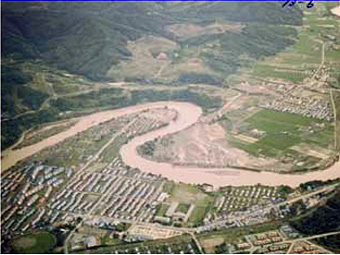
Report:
1,1,302,149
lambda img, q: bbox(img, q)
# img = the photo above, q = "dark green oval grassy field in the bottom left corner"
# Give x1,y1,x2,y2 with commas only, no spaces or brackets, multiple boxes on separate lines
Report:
11,232,56,254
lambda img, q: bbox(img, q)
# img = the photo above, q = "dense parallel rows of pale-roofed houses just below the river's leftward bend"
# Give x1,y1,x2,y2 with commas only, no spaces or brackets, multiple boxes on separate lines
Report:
48,158,162,224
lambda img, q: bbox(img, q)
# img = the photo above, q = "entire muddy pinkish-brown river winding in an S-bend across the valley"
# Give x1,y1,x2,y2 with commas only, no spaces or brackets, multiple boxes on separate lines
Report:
1,101,340,188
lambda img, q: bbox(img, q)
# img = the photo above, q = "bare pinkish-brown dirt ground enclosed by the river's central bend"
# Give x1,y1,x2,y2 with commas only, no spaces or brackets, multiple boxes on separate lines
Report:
147,123,276,167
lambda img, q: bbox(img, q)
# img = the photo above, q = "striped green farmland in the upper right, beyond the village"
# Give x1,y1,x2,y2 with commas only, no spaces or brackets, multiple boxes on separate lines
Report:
252,3,340,83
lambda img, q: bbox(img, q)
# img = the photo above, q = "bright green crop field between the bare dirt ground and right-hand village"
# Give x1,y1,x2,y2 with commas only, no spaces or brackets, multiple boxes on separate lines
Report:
230,110,334,161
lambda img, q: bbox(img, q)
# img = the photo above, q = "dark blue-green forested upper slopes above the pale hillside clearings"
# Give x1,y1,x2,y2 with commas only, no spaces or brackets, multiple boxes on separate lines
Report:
1,2,301,79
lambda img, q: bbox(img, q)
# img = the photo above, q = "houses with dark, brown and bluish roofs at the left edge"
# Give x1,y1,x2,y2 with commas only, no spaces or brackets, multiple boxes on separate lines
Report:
1,162,73,236
